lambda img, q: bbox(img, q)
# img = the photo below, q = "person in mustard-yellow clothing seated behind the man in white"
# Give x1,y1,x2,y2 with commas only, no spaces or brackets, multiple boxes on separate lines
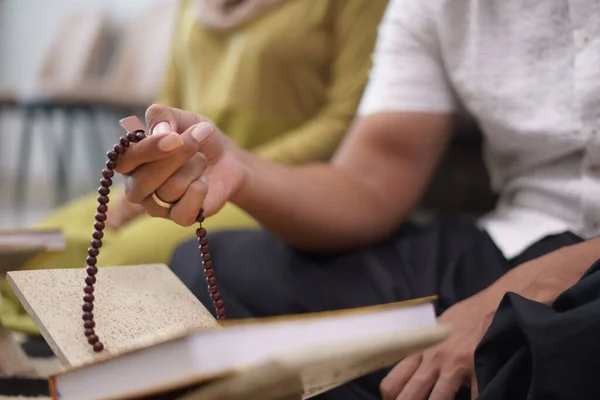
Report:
0,0,387,333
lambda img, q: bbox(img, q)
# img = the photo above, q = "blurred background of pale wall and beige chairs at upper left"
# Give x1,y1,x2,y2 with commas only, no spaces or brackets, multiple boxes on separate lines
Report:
0,0,176,229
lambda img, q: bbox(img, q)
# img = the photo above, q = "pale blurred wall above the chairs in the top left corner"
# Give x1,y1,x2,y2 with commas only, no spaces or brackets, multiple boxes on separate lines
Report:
0,0,160,90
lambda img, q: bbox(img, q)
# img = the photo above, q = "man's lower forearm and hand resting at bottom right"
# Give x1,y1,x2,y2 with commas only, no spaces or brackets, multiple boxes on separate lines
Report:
381,238,600,400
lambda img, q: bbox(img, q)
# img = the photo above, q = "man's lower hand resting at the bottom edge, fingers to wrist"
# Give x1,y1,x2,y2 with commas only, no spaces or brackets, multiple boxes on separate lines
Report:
381,297,497,400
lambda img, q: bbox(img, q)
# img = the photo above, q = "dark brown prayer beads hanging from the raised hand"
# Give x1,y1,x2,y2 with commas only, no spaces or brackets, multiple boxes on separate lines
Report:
81,125,225,353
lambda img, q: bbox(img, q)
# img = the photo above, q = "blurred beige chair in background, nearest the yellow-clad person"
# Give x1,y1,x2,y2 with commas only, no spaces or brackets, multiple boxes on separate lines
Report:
16,0,176,209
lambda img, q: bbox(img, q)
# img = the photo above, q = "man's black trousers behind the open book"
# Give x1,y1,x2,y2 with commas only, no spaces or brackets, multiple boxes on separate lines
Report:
171,216,592,400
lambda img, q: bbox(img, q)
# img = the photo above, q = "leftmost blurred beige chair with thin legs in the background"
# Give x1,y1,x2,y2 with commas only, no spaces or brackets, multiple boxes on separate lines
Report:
15,9,110,207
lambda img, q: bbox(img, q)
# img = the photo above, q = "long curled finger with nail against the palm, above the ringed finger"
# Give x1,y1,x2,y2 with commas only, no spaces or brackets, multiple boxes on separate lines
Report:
124,122,213,204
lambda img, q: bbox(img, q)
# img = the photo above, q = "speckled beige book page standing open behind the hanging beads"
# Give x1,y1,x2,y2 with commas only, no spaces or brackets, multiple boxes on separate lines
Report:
7,264,220,367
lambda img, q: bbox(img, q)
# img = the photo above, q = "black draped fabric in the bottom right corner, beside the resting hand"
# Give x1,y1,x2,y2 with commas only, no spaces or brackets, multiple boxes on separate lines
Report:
475,260,600,400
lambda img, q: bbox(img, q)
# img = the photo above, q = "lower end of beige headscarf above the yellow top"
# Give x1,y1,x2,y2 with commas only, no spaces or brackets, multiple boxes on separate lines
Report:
195,0,285,30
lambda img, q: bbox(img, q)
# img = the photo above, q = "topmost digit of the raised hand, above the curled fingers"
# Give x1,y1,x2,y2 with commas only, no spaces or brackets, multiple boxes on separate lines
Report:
146,104,210,135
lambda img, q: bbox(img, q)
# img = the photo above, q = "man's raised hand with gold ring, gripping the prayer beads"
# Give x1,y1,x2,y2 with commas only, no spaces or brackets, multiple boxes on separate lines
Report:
116,105,243,226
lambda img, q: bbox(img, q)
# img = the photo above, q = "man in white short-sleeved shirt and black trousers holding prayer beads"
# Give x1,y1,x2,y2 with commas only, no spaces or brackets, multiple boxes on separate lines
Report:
117,0,600,400
